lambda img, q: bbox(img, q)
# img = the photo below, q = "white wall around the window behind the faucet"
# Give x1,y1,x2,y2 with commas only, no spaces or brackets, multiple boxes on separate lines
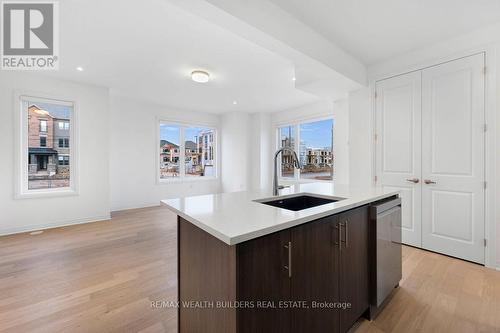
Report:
271,100,349,184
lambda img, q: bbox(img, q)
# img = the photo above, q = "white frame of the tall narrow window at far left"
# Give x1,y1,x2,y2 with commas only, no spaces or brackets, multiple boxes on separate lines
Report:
13,91,79,199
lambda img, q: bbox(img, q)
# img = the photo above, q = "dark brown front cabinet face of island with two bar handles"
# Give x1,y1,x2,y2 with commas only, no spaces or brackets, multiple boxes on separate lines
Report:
237,207,369,333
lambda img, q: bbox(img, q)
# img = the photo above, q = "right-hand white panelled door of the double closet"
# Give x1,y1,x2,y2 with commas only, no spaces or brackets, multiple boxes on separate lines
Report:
422,54,485,263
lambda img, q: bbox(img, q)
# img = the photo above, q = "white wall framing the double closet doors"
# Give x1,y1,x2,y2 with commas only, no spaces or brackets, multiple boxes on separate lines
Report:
349,24,500,269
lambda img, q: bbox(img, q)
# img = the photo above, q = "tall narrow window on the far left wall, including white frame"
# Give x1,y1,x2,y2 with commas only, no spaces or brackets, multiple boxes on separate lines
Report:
16,95,75,198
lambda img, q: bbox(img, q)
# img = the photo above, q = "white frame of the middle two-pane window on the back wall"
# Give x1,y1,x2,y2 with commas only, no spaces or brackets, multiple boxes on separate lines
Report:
155,118,220,184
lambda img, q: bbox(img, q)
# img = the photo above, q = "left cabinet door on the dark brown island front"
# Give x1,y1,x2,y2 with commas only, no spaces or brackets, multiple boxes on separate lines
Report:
237,230,291,333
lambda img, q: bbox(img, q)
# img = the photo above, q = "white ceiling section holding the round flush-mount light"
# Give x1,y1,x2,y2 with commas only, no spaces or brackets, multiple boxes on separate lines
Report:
43,0,318,113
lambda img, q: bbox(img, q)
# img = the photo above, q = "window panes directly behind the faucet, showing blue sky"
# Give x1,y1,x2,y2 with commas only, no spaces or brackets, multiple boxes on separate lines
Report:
277,119,334,180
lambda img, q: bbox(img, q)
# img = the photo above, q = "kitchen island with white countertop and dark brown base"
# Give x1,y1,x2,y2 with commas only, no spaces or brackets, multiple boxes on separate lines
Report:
162,183,400,333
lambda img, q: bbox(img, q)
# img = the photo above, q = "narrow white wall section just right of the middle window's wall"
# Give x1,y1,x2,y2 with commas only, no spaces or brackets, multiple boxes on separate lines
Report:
220,112,253,192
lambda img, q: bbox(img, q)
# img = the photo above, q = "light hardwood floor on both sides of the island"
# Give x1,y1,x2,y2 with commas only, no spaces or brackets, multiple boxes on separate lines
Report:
0,207,500,333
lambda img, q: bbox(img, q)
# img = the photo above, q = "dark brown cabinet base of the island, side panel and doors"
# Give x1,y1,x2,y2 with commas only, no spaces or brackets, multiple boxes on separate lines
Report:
179,206,370,333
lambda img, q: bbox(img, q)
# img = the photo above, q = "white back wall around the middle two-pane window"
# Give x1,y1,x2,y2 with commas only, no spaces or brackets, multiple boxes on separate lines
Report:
109,93,220,211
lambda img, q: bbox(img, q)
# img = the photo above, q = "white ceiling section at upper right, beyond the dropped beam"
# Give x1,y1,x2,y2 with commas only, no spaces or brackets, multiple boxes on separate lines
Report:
270,0,500,65
